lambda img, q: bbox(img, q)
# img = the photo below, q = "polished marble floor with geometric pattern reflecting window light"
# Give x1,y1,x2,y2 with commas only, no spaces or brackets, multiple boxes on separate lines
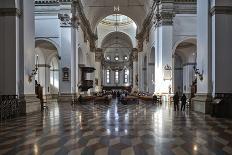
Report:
0,100,232,155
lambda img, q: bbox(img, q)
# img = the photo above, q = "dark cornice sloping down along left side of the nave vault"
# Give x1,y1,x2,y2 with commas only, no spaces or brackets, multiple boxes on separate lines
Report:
73,0,97,52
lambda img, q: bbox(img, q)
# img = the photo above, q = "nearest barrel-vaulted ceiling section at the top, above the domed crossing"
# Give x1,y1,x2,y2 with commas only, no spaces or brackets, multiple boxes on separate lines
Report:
81,0,154,31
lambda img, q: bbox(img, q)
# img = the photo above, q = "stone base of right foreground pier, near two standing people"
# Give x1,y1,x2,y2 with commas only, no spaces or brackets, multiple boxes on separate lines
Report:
192,94,213,114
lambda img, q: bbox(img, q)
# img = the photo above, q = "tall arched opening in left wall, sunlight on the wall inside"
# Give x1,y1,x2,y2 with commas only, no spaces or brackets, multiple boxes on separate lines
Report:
35,38,60,96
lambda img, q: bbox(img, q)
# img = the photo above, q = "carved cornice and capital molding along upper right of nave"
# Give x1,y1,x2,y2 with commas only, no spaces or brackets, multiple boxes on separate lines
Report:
136,0,197,52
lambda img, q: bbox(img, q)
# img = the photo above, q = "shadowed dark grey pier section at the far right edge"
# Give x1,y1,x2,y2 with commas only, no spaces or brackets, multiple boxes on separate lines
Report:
211,0,232,98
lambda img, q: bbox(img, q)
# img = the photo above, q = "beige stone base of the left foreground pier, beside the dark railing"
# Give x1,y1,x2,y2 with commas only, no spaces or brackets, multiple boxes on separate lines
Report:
20,94,41,114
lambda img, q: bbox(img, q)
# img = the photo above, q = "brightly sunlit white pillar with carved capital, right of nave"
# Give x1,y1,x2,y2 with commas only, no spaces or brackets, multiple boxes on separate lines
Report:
155,1,174,94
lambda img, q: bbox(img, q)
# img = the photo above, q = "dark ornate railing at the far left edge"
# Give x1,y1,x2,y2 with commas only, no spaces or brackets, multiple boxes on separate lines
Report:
0,95,23,121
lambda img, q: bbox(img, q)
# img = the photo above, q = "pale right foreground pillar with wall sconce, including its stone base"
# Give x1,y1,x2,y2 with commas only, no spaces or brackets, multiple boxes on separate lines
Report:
192,0,212,113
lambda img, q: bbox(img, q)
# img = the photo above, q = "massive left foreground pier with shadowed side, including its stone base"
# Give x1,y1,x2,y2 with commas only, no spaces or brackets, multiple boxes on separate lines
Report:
0,0,40,113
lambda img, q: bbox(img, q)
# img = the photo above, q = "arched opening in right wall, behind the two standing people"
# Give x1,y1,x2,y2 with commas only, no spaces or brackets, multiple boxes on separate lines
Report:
173,37,197,97
